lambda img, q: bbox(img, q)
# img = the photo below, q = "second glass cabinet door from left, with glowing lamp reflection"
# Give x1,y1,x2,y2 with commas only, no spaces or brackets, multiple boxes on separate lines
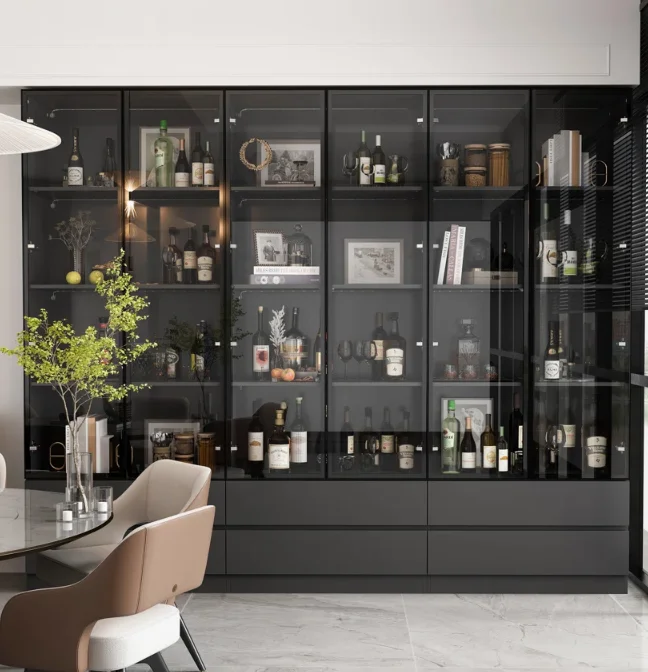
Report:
123,91,225,478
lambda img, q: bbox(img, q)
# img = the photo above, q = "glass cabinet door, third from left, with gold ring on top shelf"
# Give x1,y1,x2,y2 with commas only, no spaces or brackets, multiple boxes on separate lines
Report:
226,91,326,479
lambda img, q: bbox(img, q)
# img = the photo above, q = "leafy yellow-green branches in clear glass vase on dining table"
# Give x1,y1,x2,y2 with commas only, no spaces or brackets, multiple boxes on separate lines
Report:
0,250,156,515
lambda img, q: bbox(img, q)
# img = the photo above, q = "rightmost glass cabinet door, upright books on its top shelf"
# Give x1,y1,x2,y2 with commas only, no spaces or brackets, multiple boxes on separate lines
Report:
529,90,632,479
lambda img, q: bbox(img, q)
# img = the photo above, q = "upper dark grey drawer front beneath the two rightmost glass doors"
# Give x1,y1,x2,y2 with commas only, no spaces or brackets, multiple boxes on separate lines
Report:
428,481,630,527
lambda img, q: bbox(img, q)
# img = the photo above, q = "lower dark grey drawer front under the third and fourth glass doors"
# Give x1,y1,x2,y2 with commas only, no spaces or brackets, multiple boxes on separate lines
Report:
227,530,427,575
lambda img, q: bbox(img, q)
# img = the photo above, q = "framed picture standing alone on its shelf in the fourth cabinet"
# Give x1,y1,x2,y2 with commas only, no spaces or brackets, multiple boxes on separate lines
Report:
344,238,403,285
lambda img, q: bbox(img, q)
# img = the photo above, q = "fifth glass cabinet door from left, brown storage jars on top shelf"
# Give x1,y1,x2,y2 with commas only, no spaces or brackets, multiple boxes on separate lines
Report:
429,89,529,478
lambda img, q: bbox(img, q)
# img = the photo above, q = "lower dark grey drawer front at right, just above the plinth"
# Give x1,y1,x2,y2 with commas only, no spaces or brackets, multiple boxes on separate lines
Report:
428,530,628,576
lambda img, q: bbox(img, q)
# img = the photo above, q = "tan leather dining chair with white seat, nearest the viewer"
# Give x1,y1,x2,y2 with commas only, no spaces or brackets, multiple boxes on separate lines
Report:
0,506,215,672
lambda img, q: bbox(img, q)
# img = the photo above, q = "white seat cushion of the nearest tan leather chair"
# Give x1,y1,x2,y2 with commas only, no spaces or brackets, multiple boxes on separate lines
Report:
87,600,180,671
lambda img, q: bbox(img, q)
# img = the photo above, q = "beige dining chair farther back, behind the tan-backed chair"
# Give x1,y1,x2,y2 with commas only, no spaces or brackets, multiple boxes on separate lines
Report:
36,460,212,671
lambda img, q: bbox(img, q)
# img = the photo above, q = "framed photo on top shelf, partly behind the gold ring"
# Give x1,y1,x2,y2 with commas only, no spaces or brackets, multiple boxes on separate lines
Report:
258,140,322,188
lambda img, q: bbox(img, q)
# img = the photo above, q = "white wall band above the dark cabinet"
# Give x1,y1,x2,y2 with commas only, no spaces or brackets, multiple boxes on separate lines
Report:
0,0,640,86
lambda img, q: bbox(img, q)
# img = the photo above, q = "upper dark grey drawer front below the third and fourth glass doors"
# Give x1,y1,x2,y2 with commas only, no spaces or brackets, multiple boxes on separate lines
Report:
227,481,427,527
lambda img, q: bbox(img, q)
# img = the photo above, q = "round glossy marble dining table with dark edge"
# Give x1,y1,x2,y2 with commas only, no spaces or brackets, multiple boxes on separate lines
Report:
0,488,112,560
